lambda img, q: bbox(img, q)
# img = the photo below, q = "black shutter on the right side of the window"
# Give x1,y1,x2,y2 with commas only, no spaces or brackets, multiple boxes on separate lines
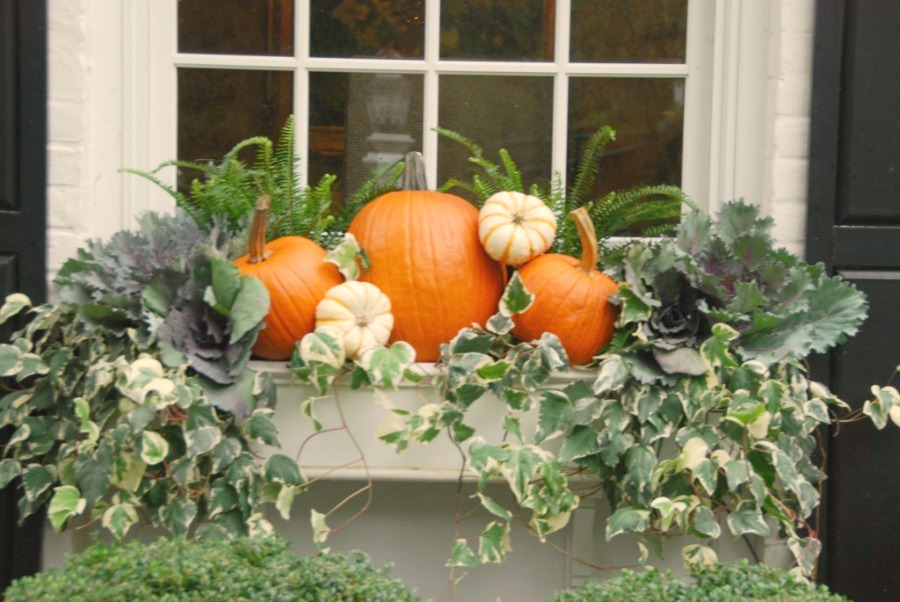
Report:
807,0,900,602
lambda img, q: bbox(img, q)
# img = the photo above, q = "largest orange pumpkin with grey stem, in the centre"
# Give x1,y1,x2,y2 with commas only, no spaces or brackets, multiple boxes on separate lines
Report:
349,153,504,362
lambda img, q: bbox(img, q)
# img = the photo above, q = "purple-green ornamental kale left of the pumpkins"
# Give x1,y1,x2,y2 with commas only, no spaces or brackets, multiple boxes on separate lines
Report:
56,211,269,415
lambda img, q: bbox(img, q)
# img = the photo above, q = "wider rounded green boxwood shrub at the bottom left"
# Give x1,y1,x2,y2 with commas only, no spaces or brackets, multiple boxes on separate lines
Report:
5,537,422,602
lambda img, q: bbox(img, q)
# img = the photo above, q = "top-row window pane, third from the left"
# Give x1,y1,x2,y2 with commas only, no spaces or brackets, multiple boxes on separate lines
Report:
441,0,556,61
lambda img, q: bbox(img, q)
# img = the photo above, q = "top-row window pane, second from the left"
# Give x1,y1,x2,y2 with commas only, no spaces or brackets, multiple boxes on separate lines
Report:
310,0,425,58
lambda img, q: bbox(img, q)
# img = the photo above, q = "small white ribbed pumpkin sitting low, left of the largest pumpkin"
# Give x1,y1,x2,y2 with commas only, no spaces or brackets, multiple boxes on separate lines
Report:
316,281,394,359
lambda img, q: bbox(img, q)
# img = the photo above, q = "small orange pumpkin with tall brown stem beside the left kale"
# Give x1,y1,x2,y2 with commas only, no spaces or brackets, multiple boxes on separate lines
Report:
234,196,344,360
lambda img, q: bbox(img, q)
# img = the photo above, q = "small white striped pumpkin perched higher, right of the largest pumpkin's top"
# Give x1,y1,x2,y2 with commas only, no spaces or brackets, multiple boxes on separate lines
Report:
478,191,556,266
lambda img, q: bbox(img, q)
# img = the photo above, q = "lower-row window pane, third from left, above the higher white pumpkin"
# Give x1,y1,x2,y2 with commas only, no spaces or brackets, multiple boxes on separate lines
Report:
432,75,553,191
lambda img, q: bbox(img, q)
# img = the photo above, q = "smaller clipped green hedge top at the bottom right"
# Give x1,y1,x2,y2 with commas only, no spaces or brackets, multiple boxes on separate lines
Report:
548,560,847,602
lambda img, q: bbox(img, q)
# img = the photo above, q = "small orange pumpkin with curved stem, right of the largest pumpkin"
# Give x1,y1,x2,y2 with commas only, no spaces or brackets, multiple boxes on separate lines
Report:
513,207,618,366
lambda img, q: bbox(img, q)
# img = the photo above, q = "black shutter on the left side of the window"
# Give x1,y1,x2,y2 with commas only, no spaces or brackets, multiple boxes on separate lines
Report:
0,0,47,592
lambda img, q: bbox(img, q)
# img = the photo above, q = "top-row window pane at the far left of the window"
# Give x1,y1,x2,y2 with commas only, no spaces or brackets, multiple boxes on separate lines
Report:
178,0,294,56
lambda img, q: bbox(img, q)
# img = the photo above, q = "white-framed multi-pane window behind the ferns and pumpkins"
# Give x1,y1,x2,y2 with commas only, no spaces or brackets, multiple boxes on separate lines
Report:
123,0,758,221
